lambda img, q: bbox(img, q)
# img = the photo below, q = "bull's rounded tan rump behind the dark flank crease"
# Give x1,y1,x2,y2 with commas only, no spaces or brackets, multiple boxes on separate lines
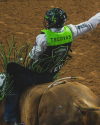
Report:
38,82,100,125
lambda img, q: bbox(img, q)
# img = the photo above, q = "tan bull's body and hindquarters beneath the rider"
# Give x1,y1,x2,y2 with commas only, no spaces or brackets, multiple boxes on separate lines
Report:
20,82,100,125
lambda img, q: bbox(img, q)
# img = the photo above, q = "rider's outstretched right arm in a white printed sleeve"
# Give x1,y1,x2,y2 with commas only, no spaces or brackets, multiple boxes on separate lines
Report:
68,12,100,39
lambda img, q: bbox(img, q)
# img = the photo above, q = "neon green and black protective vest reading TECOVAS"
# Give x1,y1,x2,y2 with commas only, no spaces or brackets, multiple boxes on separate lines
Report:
33,26,72,73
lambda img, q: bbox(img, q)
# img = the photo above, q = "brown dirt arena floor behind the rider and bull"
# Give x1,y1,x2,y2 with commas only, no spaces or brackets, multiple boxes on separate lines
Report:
0,0,100,125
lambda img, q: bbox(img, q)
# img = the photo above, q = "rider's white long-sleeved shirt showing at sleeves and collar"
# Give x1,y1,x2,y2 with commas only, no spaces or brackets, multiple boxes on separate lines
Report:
29,12,100,60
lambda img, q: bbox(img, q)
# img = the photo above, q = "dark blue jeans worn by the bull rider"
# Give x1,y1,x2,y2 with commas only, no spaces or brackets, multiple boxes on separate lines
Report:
4,73,53,122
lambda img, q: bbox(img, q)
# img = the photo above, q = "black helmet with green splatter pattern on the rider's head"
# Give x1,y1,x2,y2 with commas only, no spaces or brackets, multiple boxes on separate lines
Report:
43,8,67,29
